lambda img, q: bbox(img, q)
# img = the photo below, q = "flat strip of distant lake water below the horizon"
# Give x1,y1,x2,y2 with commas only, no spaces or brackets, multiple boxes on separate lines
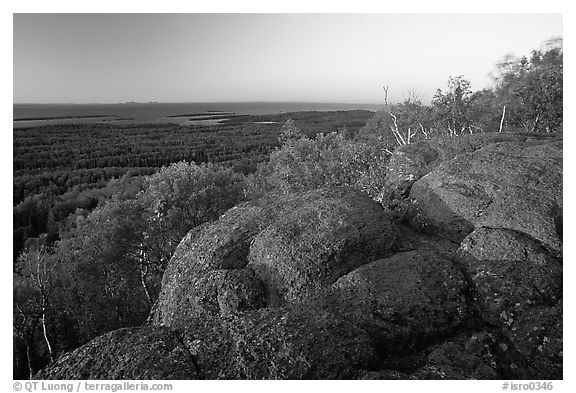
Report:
13,102,382,127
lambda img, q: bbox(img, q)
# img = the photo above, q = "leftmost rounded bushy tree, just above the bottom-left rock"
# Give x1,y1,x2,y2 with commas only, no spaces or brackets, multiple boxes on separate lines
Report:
54,200,151,345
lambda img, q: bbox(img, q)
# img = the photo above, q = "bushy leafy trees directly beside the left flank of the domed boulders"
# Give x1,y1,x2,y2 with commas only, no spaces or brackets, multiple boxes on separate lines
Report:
56,162,249,340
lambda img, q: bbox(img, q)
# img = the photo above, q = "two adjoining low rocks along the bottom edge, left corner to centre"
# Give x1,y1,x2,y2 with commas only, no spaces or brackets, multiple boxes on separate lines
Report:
36,309,376,380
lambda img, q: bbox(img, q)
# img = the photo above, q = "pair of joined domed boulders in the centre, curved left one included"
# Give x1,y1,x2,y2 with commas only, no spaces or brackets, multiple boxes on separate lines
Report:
153,188,397,329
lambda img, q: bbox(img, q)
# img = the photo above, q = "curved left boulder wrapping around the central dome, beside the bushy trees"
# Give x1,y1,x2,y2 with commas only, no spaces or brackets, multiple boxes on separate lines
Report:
150,194,296,328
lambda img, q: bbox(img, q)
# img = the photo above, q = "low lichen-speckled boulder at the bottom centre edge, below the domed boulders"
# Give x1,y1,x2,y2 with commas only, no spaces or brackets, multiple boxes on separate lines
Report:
184,309,376,379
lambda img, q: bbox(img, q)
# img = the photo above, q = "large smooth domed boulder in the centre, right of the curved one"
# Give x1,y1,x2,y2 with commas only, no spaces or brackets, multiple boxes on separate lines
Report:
248,189,398,307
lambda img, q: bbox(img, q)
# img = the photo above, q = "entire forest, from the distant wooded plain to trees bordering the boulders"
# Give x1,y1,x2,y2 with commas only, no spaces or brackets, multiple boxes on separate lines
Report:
13,41,563,378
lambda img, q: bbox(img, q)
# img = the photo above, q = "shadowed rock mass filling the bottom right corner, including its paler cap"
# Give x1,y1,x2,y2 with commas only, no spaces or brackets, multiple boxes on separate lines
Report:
458,228,562,378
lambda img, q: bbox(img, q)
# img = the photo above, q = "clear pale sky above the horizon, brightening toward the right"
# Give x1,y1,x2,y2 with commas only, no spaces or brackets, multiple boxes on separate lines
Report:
13,14,562,103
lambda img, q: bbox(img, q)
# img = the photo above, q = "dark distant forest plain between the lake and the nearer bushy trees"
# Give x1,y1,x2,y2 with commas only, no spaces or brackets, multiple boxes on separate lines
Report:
13,110,371,263
